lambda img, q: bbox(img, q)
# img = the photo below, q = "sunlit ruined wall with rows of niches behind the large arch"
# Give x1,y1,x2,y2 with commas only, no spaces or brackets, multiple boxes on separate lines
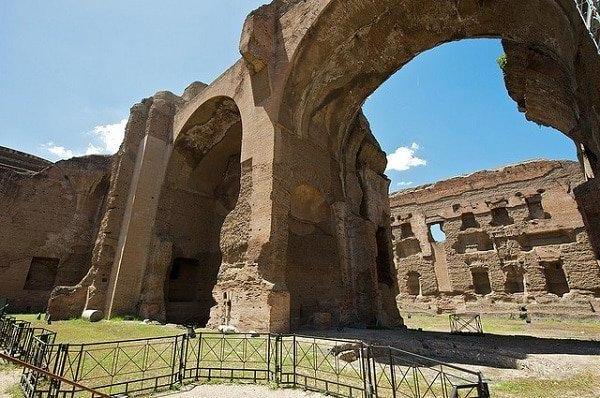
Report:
390,161,600,316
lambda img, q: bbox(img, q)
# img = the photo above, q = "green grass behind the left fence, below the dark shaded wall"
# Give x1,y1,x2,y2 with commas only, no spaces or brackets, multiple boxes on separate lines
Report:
15,314,180,343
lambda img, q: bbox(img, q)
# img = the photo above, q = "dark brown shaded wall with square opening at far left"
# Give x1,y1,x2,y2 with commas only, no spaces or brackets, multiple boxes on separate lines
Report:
0,154,112,312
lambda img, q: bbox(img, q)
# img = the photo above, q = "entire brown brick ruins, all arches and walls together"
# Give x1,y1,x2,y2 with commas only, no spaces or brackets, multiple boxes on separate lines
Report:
0,0,600,332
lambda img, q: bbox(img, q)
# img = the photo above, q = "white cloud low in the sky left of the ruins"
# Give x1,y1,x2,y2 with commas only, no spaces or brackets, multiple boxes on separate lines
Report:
42,119,127,160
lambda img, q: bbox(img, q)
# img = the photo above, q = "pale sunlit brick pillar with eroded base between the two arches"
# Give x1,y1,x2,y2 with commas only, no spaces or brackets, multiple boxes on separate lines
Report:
208,105,290,332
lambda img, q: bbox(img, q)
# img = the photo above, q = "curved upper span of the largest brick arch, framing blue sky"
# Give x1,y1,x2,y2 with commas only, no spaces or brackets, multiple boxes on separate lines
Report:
279,0,600,162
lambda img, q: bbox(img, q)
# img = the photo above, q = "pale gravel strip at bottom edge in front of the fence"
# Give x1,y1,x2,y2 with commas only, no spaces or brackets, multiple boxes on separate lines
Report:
165,384,325,398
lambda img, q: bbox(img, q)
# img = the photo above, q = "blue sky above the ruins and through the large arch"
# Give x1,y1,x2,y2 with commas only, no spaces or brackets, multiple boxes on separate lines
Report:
0,0,575,190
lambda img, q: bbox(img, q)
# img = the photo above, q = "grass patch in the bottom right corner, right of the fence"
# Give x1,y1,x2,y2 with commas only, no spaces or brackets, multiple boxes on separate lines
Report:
491,373,600,398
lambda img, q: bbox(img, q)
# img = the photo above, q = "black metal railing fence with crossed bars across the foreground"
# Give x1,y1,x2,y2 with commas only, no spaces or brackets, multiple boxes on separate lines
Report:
0,318,489,398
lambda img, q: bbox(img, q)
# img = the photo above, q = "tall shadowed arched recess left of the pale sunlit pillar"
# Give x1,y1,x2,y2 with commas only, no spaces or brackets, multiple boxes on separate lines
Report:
155,97,242,326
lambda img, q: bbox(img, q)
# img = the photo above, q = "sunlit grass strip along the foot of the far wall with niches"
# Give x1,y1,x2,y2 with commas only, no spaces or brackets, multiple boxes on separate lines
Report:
402,314,600,340
